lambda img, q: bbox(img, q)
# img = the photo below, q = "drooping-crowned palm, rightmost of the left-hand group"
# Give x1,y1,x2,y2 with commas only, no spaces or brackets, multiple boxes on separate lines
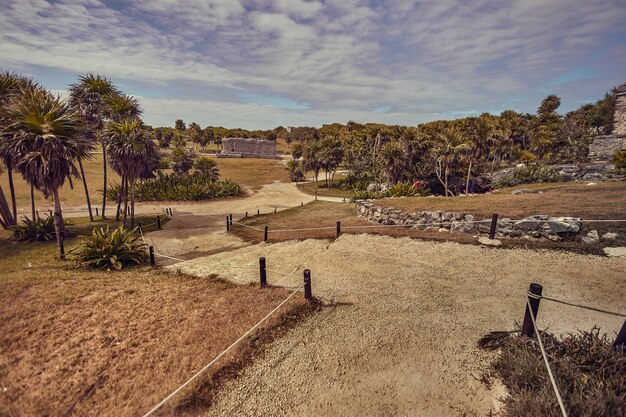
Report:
103,119,157,227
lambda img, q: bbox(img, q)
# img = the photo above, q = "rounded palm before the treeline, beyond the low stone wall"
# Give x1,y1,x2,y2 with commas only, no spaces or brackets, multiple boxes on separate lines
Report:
433,127,468,197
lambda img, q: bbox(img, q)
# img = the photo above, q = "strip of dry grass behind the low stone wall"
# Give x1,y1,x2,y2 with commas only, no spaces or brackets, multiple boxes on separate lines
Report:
377,182,626,219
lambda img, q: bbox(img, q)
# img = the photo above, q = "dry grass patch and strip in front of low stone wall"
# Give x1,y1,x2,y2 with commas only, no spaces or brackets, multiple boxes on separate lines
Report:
233,199,626,255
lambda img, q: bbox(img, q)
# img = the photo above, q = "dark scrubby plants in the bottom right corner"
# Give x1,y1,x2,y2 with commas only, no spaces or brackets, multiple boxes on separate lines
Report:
486,329,626,417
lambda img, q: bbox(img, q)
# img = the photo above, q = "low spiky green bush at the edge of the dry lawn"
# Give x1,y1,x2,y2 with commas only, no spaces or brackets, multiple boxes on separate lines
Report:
72,225,147,271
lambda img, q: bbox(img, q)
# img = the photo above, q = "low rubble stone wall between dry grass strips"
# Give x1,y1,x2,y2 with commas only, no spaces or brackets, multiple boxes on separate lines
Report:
356,200,582,241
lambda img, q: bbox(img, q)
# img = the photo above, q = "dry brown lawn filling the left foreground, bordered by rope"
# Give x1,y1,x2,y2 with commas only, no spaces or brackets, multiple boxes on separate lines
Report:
0,219,310,416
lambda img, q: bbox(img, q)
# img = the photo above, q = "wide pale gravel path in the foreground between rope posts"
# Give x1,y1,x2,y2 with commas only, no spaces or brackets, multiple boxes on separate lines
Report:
172,235,626,416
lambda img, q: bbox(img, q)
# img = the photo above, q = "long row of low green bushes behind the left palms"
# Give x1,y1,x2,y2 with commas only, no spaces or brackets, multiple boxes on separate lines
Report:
107,172,243,201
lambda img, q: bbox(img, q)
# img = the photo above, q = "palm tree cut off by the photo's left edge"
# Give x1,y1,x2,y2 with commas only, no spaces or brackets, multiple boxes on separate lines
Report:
0,71,34,224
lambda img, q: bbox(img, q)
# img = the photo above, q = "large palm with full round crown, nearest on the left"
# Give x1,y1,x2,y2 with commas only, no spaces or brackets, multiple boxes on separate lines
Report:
0,87,93,259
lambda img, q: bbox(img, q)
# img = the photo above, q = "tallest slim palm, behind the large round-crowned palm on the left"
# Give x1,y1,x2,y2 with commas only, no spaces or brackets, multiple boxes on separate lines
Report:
70,73,119,219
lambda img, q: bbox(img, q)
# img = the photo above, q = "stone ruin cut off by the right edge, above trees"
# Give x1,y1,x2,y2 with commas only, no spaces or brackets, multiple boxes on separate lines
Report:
589,83,626,162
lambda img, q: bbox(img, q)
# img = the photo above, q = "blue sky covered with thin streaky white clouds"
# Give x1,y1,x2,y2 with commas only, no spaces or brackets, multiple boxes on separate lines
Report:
0,0,626,129
